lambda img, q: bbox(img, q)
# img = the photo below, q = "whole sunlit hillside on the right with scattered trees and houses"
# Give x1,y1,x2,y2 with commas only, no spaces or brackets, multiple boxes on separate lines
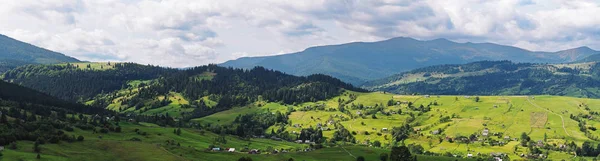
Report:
193,91,600,160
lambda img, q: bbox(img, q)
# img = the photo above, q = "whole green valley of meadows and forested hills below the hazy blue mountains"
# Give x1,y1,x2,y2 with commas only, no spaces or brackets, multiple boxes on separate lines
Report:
0,35,600,161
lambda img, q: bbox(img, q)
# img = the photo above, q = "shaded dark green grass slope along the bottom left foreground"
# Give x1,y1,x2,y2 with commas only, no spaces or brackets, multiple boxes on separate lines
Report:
0,122,454,161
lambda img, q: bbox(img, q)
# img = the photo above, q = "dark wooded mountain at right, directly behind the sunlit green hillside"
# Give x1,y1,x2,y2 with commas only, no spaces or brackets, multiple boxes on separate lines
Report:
362,61,600,98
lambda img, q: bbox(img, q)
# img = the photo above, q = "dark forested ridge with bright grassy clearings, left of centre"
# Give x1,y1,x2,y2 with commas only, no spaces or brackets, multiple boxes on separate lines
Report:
3,63,364,118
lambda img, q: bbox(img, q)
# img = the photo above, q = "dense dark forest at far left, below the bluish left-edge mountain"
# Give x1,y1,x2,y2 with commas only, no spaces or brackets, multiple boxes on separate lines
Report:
3,63,177,101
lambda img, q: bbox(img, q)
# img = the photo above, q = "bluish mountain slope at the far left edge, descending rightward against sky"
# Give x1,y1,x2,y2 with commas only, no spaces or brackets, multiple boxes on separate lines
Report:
0,34,80,73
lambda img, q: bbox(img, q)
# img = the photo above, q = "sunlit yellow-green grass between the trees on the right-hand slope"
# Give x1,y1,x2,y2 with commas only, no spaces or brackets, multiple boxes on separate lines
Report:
189,92,600,160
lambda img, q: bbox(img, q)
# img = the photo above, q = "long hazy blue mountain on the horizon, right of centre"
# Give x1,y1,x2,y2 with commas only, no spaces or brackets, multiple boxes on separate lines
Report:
220,37,597,85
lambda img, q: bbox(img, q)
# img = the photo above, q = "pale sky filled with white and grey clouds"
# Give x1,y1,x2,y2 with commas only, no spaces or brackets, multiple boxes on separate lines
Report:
0,0,600,67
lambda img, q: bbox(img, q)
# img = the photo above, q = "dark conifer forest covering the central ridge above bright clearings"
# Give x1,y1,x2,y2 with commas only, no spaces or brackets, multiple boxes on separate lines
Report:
95,65,364,118
